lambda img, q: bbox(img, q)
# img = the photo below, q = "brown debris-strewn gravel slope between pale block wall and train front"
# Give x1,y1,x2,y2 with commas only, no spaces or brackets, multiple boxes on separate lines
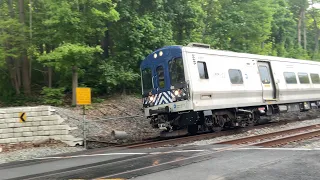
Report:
53,96,160,143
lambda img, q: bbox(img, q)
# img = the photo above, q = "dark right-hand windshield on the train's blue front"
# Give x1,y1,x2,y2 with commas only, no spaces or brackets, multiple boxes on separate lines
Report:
169,58,185,87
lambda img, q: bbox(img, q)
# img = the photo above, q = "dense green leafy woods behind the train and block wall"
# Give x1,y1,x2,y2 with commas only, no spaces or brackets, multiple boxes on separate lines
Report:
0,0,320,104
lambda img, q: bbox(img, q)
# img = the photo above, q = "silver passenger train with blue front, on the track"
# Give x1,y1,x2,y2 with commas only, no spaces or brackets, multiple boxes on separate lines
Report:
140,43,320,134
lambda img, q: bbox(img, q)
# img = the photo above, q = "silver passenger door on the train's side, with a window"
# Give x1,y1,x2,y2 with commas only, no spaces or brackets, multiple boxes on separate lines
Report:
258,62,276,101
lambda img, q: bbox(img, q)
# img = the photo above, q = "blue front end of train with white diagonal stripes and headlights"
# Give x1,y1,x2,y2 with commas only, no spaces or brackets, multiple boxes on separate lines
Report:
140,46,188,116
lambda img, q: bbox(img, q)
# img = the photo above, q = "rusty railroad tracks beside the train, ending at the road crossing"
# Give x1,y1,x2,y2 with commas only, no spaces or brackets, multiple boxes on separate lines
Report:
116,122,320,149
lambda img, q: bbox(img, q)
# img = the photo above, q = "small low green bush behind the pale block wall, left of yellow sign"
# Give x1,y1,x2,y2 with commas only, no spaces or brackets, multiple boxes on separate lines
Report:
41,87,65,106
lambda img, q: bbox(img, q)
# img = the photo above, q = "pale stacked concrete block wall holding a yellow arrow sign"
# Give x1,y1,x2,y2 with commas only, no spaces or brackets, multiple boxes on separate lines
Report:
0,106,83,146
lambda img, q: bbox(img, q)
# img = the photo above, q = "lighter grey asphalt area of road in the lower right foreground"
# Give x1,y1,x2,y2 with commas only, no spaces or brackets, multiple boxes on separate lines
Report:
135,149,320,180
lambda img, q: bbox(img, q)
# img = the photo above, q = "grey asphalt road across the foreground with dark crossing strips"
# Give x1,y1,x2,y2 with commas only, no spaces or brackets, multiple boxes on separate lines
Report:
0,146,320,180
